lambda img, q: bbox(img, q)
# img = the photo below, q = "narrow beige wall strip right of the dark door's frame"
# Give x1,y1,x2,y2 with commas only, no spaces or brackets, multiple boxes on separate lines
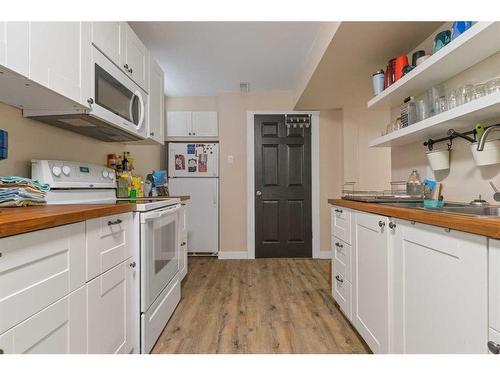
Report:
319,110,343,251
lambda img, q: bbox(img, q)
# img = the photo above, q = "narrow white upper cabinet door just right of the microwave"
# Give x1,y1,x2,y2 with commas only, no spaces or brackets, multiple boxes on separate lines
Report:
148,57,165,144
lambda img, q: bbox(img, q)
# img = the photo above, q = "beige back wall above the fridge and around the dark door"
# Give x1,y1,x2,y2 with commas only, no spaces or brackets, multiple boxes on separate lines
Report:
166,91,342,251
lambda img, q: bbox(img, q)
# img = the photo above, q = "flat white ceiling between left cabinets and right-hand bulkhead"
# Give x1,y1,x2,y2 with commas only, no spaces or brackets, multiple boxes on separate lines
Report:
130,22,321,96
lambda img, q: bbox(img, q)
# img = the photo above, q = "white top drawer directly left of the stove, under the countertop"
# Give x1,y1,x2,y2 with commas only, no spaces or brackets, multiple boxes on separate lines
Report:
87,213,135,280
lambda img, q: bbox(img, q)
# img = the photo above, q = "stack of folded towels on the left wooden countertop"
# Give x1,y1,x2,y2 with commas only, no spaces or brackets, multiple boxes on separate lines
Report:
0,176,50,207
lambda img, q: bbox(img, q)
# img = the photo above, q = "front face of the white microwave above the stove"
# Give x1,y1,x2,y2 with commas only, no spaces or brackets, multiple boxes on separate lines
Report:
90,47,148,137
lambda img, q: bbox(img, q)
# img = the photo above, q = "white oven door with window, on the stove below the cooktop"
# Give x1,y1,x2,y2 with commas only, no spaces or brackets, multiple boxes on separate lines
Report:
141,204,181,312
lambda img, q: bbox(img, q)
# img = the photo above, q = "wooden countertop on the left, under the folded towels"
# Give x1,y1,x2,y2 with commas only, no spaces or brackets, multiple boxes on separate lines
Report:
0,195,191,238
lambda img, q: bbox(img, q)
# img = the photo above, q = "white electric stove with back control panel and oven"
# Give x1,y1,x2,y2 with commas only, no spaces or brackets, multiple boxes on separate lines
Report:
31,160,181,353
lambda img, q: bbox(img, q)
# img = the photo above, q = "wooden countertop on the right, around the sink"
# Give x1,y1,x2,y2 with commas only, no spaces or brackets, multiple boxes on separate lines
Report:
328,199,500,239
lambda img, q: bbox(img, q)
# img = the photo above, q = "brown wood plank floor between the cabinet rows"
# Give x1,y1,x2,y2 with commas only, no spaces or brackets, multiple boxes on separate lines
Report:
153,257,369,354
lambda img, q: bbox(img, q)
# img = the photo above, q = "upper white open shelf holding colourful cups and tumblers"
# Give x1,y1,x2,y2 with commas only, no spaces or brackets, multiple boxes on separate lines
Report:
368,22,500,108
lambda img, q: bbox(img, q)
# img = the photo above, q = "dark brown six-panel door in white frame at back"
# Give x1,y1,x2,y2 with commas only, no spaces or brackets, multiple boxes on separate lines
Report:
254,115,312,258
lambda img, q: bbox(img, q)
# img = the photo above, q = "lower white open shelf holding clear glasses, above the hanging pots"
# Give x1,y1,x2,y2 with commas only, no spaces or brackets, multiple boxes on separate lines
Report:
368,93,500,147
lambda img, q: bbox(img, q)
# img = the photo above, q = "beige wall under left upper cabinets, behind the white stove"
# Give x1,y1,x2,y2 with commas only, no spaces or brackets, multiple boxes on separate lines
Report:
0,103,162,177
